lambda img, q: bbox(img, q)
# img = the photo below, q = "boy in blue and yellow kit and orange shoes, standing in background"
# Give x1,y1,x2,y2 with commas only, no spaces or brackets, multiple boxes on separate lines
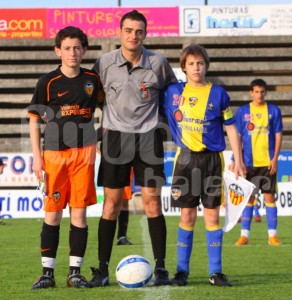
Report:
235,79,283,246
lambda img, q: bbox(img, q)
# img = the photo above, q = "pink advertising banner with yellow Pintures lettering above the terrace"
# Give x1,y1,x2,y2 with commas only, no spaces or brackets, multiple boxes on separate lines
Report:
48,7,179,38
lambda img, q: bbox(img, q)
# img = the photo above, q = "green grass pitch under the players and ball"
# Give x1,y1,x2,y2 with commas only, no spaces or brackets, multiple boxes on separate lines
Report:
0,215,292,300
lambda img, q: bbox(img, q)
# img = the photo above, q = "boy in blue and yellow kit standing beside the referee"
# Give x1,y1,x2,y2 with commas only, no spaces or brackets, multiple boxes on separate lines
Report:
162,44,244,286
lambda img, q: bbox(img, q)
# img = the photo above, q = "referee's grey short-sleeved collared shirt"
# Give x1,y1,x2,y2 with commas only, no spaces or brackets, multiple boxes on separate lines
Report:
93,47,177,133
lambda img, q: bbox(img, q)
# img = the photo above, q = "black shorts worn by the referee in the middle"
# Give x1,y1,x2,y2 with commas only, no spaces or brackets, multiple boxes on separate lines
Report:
98,128,165,188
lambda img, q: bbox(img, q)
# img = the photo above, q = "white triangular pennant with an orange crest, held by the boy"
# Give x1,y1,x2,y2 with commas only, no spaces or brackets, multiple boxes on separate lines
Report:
222,170,255,232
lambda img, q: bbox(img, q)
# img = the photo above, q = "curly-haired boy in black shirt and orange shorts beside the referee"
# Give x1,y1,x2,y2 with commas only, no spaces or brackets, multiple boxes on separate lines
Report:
28,26,104,290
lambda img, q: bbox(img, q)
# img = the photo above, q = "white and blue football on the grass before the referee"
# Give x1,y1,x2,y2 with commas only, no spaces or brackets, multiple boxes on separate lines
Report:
116,255,153,289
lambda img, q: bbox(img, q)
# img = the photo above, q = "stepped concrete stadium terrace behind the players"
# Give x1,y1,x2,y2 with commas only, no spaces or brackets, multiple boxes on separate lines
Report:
0,35,292,153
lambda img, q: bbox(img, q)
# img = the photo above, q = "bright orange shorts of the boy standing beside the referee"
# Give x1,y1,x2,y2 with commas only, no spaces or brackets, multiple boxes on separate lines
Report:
44,145,96,212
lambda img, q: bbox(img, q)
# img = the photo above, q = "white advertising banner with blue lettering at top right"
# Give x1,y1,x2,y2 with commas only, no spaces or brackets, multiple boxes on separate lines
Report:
180,1,292,36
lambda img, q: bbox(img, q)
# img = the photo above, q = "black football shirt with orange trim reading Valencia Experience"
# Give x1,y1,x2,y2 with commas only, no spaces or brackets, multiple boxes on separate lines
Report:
28,66,104,150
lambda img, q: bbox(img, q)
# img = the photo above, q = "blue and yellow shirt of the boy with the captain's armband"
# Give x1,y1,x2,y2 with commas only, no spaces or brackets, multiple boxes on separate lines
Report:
162,82,235,152
